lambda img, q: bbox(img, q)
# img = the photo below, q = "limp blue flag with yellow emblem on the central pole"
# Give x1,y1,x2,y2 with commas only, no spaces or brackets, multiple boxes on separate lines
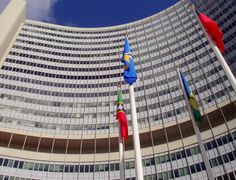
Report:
121,37,138,85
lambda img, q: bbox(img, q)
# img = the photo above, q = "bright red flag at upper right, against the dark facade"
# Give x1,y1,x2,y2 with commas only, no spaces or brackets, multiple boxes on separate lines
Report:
197,12,225,53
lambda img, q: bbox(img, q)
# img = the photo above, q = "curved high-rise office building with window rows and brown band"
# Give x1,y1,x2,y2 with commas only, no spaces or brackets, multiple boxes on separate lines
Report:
0,0,236,180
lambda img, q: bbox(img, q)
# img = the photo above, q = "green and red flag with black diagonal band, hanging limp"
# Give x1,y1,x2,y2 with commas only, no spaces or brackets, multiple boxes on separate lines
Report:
116,91,128,139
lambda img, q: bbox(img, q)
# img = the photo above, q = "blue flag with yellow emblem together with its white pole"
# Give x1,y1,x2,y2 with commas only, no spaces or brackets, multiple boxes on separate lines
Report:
121,37,143,180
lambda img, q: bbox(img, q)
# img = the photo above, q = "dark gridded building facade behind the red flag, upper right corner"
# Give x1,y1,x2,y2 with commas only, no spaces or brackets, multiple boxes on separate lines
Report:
191,0,236,76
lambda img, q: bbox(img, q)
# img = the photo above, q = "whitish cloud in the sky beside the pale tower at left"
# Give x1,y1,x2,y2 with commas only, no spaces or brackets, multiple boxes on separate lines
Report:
27,0,58,23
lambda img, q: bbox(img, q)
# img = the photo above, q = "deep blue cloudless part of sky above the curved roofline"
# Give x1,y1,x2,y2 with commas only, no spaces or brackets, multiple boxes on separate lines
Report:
54,0,177,27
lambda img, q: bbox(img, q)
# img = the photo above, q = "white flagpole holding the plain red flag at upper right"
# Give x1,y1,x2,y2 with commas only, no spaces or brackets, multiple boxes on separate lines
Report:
191,4,236,92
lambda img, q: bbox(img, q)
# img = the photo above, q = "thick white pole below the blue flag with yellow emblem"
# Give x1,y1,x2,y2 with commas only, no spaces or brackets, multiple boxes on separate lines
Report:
129,85,143,180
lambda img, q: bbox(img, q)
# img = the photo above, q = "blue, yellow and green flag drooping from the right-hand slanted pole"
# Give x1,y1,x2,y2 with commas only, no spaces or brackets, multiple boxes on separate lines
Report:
179,70,202,122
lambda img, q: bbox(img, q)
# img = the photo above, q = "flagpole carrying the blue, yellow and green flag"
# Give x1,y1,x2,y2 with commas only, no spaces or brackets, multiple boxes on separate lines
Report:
177,67,214,180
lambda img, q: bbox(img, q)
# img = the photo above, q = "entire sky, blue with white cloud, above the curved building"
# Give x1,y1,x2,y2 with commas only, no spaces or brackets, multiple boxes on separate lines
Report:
0,0,178,27
